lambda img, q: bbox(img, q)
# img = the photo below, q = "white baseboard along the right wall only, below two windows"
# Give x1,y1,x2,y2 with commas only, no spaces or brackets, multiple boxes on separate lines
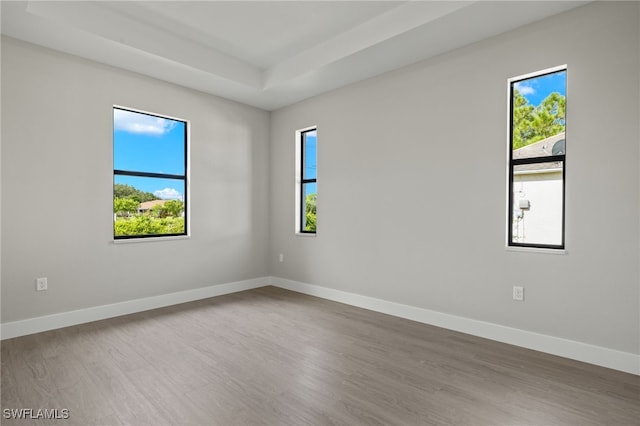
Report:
271,277,640,375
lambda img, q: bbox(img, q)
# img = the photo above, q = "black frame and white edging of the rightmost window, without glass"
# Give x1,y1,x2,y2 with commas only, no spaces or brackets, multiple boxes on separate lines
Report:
506,64,568,253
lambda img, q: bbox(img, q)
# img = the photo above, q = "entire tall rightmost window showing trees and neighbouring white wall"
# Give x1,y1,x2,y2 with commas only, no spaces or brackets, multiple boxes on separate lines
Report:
507,65,567,249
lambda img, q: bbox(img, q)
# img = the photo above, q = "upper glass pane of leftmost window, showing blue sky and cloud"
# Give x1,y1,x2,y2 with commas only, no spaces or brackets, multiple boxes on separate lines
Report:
113,108,186,175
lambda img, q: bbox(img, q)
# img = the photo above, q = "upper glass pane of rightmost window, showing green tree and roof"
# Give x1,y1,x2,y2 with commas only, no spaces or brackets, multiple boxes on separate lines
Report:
511,70,567,159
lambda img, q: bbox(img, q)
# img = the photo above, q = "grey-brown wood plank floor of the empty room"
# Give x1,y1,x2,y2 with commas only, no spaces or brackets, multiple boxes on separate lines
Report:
0,287,640,426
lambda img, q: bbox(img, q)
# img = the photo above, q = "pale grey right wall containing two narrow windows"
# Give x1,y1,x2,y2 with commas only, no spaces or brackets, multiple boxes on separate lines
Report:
269,2,640,354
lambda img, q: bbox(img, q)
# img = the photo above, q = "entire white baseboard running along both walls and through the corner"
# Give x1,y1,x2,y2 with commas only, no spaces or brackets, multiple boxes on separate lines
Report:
0,277,640,375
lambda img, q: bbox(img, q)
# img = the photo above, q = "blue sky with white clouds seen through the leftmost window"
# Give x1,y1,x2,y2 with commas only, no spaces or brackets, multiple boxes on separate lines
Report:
113,108,186,199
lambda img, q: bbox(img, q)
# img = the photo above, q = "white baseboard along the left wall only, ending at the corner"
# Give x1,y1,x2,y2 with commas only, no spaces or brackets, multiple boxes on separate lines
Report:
0,277,271,340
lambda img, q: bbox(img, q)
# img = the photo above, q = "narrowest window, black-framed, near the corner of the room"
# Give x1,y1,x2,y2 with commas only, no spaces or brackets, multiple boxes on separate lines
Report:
296,127,318,234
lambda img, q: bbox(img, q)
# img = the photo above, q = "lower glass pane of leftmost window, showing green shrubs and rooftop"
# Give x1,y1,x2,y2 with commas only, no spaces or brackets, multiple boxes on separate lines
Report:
113,175,186,237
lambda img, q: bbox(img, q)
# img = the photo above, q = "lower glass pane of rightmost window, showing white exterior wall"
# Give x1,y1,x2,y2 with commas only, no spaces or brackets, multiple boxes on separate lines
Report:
511,161,564,245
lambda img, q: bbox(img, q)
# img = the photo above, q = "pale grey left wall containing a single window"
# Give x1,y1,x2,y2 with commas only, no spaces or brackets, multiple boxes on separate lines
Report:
2,38,269,323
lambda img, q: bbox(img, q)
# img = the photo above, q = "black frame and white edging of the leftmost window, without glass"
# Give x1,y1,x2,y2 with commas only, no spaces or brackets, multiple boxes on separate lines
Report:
111,105,191,242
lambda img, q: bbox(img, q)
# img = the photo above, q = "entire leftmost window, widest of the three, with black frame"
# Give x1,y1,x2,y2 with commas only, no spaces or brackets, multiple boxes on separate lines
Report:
113,106,189,239
